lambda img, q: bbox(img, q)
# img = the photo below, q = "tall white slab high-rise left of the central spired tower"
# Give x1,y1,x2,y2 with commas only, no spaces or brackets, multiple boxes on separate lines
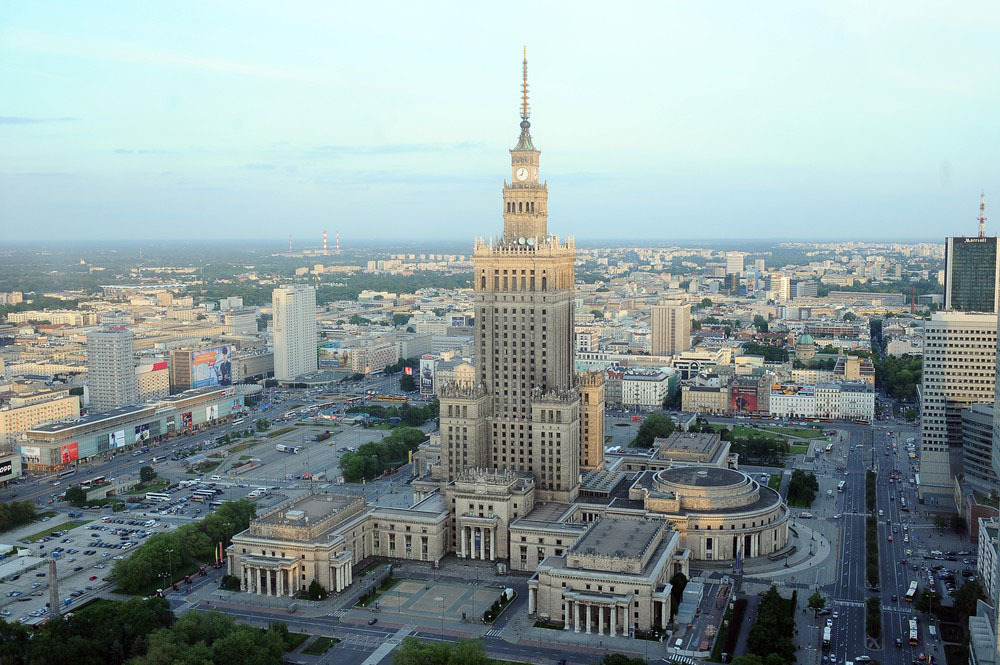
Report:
271,284,319,381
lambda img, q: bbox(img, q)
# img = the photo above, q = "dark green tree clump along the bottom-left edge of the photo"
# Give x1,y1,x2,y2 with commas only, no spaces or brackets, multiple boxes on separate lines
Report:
0,598,297,665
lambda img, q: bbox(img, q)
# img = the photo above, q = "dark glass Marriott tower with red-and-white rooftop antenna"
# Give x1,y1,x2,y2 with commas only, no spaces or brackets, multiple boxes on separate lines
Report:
944,198,1000,312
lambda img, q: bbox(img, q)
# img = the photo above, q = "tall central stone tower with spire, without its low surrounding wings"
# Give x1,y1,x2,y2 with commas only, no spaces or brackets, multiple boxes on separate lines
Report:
441,50,580,501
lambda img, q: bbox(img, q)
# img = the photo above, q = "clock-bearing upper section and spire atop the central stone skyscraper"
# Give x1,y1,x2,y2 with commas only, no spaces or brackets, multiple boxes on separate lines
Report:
503,50,549,244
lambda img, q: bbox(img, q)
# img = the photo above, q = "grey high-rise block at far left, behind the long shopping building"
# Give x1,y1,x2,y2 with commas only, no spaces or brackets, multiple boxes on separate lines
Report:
87,323,139,411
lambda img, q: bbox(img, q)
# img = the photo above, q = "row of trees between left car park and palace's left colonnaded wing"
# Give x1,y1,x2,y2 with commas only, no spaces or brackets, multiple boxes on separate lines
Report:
108,499,256,593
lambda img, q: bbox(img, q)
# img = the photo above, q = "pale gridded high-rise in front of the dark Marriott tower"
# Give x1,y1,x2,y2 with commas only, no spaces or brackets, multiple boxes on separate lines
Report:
917,312,997,504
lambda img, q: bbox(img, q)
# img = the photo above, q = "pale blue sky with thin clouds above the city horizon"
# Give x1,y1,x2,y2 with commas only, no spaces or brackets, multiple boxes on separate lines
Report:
0,0,1000,247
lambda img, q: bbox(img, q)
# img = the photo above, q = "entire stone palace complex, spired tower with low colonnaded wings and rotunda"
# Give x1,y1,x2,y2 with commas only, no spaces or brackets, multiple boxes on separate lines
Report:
227,54,788,635
